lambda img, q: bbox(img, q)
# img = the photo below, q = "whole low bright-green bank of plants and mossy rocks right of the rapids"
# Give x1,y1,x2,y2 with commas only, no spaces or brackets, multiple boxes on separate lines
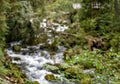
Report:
44,50,120,84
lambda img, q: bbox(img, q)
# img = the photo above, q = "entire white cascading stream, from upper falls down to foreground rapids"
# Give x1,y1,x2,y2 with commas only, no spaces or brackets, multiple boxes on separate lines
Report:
6,21,76,84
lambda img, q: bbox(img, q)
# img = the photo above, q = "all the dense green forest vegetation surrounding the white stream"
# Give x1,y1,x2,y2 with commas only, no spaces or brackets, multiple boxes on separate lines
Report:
0,0,120,84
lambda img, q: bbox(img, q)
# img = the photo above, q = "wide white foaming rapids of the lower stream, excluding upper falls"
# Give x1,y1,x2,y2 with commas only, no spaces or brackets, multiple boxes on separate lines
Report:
6,44,65,84
